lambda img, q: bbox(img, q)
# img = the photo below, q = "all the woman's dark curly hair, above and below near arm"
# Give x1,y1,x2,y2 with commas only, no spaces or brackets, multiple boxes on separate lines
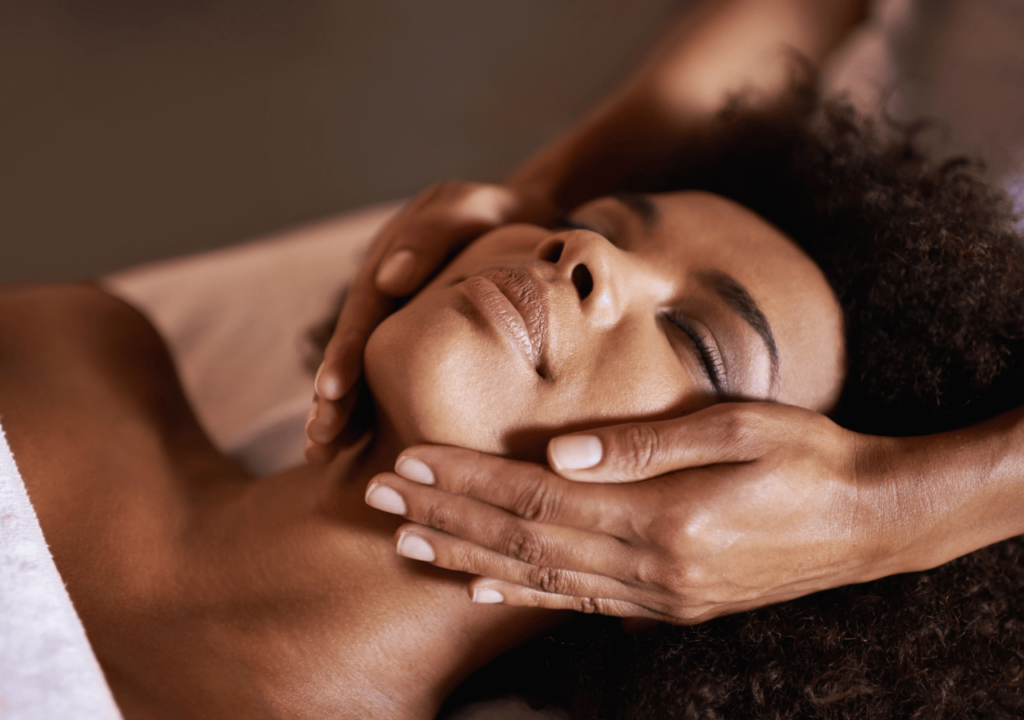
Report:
446,89,1024,720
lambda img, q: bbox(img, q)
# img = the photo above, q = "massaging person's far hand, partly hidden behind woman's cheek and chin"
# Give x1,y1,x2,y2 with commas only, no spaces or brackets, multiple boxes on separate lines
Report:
305,180,553,462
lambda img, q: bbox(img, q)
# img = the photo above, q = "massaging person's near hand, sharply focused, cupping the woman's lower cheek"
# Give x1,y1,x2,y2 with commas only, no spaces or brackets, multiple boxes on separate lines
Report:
367,403,920,624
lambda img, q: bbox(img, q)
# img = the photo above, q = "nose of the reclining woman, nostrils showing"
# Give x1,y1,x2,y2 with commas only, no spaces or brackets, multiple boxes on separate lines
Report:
538,229,626,326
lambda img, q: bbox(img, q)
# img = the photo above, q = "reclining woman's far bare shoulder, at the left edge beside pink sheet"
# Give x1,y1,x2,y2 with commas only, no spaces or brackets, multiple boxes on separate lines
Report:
0,284,226,533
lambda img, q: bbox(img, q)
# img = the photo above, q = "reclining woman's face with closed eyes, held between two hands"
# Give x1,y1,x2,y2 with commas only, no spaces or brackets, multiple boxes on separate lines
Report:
366,192,845,458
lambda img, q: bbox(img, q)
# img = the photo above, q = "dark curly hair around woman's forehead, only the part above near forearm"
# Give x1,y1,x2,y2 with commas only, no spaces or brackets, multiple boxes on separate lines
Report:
627,82,1024,435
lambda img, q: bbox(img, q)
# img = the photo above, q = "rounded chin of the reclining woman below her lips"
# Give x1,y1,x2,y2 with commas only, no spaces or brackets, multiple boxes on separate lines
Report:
364,303,524,455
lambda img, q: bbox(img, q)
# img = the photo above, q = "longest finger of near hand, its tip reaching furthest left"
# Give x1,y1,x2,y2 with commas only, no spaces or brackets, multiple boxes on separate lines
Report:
366,473,641,585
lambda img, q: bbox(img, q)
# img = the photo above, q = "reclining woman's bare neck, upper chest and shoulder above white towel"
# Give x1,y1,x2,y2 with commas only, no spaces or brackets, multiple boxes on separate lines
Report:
0,285,557,720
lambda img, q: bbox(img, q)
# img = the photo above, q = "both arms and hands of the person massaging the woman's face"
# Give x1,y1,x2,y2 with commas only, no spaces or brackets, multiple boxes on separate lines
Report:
307,0,1024,623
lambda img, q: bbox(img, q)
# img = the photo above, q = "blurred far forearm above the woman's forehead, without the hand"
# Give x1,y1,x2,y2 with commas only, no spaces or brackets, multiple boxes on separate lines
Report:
510,0,867,207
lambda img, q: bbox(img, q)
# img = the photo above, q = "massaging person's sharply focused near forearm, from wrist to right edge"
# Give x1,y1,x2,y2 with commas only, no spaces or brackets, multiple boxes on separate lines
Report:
861,408,1024,574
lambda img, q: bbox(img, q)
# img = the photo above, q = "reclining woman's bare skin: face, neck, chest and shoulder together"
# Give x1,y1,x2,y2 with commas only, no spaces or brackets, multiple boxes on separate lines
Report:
0,193,844,720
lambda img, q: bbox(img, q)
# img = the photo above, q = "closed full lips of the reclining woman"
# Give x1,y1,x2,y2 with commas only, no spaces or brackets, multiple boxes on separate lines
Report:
463,267,548,377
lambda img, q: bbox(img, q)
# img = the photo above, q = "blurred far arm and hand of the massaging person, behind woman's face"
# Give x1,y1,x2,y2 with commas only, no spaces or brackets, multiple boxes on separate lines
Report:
307,0,868,450
